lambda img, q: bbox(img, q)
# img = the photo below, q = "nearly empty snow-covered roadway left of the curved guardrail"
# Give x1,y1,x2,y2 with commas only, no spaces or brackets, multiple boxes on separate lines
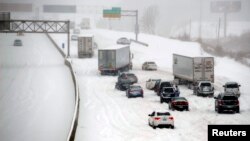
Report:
0,33,75,141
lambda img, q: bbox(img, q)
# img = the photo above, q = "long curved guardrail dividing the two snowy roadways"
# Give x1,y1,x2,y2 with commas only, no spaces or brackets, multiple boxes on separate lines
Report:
46,33,80,141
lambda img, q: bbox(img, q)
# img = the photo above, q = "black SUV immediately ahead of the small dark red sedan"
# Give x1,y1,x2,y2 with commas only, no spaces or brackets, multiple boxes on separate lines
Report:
160,87,178,103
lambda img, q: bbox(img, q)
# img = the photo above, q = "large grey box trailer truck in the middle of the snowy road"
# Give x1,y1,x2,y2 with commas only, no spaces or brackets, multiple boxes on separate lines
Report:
98,45,132,75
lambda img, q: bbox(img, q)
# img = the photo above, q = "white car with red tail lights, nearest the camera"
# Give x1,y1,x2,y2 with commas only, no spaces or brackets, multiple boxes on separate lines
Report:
148,111,174,129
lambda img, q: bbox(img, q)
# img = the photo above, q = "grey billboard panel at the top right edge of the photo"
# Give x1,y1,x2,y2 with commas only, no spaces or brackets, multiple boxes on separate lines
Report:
210,1,241,13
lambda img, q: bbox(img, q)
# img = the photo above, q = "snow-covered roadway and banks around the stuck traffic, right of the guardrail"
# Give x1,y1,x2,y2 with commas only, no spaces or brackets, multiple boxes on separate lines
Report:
53,29,250,141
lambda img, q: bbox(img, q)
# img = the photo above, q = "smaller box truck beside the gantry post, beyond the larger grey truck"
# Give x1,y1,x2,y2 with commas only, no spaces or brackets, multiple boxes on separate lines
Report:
78,35,94,58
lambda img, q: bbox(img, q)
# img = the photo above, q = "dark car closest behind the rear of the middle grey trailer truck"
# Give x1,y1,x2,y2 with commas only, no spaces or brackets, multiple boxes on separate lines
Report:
118,72,138,84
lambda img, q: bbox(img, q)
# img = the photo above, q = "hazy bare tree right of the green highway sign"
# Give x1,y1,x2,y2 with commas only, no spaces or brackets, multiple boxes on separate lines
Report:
142,5,159,34
